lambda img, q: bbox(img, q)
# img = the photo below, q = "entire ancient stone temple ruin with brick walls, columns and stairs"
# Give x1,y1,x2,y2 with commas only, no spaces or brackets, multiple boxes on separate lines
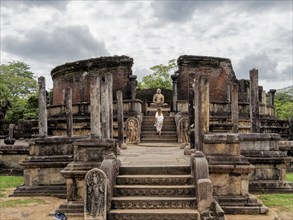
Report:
1,55,293,220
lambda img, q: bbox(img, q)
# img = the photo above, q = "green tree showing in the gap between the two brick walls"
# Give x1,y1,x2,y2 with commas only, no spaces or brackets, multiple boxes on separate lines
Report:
138,59,177,89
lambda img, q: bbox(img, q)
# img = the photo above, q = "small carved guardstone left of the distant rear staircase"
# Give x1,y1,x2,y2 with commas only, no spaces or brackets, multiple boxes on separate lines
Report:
125,117,140,144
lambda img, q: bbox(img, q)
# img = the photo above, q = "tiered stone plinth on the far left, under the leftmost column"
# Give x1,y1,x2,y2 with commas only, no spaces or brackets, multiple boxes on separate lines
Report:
12,137,80,198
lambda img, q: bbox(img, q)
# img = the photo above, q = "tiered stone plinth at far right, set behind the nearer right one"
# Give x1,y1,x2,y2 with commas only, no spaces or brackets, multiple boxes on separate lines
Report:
239,133,293,193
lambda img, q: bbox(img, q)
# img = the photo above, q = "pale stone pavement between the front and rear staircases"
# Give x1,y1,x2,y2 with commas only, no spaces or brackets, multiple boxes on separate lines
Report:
118,143,190,166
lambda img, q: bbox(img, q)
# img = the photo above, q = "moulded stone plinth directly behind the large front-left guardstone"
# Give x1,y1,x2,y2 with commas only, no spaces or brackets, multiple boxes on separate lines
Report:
56,138,117,218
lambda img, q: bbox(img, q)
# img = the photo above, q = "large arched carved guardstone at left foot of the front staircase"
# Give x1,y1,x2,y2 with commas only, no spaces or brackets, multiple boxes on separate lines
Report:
84,168,107,220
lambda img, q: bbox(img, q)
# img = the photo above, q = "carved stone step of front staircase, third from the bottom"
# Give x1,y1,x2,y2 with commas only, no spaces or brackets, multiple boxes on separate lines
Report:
114,185,195,197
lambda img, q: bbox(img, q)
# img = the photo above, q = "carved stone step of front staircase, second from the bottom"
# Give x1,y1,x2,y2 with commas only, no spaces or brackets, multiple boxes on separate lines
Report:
111,197,197,209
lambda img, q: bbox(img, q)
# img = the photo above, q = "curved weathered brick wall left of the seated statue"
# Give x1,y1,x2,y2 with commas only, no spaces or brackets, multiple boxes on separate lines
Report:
51,56,133,105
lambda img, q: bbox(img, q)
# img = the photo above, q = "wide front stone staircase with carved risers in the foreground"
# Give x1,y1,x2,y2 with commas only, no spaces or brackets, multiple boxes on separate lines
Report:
108,166,199,220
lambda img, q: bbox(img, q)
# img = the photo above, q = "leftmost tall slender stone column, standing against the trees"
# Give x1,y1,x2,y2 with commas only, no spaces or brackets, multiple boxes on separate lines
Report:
38,76,48,138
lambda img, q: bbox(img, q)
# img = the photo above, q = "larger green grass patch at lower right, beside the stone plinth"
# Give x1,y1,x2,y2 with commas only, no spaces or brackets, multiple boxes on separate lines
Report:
258,193,293,212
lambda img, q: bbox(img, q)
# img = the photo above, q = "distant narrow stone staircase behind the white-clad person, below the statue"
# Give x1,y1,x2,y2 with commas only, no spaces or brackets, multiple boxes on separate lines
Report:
141,116,178,143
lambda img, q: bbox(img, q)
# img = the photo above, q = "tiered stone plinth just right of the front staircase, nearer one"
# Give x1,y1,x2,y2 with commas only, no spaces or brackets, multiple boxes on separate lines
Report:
203,133,268,214
